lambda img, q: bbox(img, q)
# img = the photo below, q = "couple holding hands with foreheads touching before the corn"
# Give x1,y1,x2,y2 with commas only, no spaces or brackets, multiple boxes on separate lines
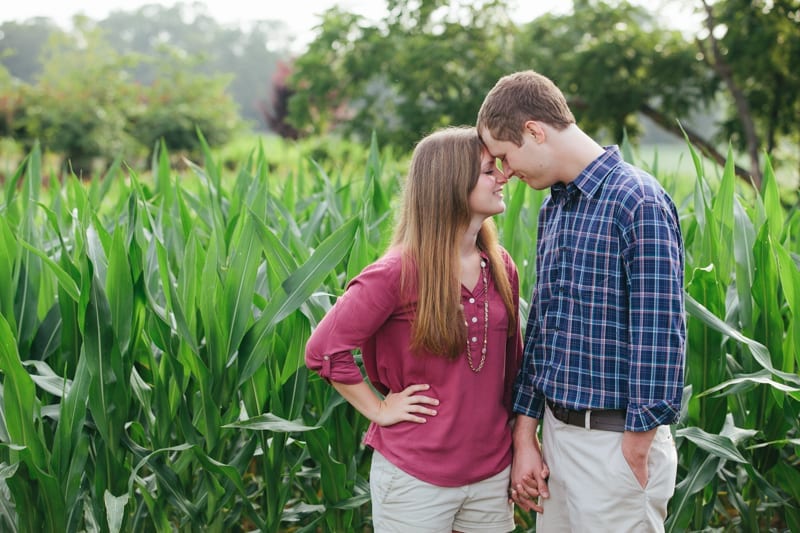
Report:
306,71,685,533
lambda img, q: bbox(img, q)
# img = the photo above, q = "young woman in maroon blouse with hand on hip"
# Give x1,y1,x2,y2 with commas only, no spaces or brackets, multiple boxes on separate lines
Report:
306,127,522,532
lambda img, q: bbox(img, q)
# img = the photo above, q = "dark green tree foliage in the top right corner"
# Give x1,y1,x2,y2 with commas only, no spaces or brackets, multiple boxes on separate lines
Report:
697,0,800,186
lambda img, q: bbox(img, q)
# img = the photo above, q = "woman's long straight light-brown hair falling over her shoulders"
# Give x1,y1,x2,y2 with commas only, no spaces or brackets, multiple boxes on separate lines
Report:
392,127,517,358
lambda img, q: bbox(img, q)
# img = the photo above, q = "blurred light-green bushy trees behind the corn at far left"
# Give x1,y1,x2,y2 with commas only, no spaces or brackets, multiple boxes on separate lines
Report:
3,18,240,175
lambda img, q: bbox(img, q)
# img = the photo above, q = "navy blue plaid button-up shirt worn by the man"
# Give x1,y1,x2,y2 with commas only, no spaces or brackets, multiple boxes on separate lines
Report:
514,146,686,431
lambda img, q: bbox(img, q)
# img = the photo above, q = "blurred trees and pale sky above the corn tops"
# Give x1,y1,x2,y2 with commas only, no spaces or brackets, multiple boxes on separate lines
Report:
0,0,800,189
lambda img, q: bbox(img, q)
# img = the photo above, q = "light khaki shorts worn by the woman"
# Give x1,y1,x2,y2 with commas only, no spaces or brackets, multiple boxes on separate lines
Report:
369,451,514,533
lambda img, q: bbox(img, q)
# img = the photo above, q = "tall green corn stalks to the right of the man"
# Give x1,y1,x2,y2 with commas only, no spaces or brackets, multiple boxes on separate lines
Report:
656,142,800,531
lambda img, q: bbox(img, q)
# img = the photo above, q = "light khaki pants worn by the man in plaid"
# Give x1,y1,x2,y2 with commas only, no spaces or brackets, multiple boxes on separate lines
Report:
536,407,678,533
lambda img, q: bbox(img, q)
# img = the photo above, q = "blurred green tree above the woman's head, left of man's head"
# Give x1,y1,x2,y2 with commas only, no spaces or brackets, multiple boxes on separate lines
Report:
289,0,514,149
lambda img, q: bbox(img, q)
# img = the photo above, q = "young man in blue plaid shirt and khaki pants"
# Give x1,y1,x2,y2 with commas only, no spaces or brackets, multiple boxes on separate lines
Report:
477,71,686,533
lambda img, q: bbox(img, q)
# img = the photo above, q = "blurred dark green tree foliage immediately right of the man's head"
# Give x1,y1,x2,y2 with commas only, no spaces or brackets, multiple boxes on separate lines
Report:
513,0,717,143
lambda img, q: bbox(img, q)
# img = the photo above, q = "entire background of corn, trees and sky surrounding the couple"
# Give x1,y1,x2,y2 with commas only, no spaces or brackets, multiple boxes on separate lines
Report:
0,0,800,533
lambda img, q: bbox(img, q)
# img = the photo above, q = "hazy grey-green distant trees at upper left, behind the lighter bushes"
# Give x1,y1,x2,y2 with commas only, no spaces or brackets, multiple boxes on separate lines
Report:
0,2,292,129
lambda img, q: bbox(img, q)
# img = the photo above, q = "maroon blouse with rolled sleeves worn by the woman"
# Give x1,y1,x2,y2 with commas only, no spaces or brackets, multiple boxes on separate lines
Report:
306,250,522,487
